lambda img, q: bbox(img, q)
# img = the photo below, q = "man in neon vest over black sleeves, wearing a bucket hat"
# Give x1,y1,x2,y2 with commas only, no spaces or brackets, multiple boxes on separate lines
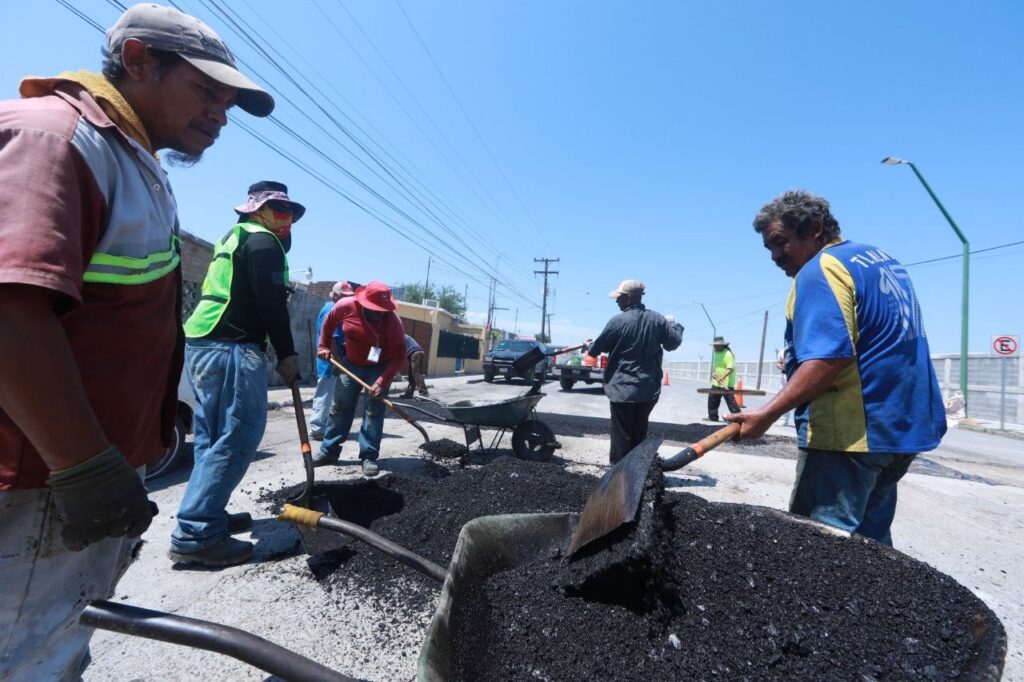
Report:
169,180,305,566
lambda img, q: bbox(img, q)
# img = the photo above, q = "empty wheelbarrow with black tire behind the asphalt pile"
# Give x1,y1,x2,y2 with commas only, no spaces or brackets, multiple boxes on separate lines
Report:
389,384,562,462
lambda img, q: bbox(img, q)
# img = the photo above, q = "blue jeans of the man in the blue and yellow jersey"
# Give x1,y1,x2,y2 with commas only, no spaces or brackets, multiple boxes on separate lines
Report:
790,450,916,547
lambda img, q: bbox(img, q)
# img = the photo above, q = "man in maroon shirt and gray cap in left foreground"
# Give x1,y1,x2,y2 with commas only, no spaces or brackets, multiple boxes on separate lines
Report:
0,4,273,680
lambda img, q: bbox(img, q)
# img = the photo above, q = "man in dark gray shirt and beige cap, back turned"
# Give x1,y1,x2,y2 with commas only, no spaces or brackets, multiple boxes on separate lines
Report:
587,280,683,464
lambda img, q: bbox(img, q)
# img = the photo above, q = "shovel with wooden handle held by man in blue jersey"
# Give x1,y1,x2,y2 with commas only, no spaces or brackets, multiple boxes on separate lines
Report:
568,424,739,556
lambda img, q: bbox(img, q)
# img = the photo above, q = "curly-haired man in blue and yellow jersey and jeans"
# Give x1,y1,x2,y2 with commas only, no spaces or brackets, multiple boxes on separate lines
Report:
726,191,946,545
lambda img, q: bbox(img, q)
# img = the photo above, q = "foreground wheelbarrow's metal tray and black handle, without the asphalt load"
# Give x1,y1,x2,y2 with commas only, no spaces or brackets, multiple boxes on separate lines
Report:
82,509,1007,682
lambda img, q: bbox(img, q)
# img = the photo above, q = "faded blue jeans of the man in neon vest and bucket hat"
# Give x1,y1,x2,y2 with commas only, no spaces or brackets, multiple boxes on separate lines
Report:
171,339,267,553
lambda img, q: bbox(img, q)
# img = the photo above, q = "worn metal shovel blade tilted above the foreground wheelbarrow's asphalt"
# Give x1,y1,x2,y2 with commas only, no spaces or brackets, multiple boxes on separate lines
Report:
569,438,662,556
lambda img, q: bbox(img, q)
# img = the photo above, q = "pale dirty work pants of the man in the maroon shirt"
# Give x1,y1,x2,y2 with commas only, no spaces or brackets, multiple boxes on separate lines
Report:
0,481,142,682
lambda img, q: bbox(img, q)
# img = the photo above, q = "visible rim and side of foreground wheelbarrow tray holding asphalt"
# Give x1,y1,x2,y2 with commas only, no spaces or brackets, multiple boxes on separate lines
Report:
417,508,1007,682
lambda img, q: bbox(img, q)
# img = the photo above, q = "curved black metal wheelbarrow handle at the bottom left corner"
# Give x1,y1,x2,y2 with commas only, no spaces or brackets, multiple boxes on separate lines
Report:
79,601,355,682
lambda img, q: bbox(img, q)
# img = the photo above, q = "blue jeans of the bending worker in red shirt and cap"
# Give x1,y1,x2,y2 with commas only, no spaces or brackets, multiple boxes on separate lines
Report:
321,359,388,460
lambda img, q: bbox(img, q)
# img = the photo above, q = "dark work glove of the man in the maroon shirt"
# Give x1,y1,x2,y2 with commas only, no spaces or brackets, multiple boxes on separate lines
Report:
46,445,159,552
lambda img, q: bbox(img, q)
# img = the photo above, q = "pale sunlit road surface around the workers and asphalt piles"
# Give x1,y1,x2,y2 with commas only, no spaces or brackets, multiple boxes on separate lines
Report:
85,378,1024,681
